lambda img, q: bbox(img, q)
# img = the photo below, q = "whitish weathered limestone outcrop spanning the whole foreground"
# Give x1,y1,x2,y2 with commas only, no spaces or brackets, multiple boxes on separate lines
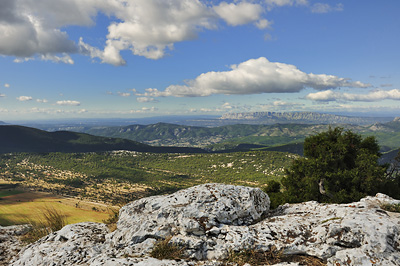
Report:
5,184,400,266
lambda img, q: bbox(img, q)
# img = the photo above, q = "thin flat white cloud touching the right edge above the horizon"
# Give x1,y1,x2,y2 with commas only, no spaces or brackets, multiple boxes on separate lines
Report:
306,89,400,102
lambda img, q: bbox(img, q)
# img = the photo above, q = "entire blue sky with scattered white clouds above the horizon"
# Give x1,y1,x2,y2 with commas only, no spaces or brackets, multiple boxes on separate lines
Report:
0,0,400,121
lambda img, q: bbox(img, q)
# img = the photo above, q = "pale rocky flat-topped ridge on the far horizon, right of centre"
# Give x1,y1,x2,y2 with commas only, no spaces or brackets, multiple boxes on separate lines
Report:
220,112,393,125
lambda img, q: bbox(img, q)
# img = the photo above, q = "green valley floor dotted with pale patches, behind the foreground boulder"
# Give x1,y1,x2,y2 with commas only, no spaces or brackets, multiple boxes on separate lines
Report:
0,151,297,204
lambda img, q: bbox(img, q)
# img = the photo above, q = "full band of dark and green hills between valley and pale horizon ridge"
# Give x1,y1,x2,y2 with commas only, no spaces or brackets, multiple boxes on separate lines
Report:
0,119,400,163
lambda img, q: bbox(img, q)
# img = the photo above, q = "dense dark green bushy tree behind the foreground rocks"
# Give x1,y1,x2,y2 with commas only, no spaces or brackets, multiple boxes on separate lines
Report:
282,127,387,203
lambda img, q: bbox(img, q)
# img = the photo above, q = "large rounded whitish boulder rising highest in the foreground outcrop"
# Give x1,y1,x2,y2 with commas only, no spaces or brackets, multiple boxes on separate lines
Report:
111,184,270,245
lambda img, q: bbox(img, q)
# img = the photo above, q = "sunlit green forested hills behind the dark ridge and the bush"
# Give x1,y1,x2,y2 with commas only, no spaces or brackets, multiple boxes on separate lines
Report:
61,120,400,151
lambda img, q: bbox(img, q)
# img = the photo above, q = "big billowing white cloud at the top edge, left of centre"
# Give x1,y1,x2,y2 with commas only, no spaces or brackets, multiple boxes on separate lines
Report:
79,0,216,65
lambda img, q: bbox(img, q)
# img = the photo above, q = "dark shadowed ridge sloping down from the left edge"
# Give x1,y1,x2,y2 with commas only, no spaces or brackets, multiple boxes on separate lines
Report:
0,126,204,153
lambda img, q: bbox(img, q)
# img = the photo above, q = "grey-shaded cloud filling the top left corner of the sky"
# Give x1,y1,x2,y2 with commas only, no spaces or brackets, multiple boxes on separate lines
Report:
0,0,77,61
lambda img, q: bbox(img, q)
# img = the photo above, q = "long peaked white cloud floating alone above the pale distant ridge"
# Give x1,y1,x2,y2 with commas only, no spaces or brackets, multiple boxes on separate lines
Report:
152,57,370,97
